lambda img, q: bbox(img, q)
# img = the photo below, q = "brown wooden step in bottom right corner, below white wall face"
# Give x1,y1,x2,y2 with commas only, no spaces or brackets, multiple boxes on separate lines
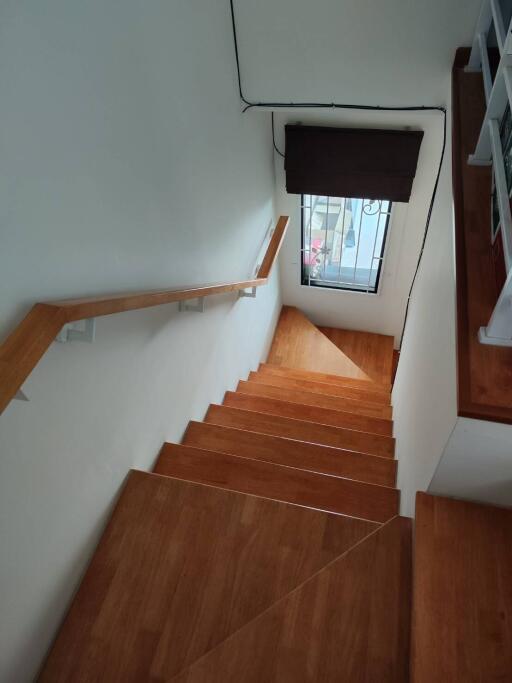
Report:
412,493,512,683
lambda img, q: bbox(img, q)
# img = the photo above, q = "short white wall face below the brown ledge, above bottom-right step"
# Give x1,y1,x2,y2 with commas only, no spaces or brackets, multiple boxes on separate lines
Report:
428,417,512,507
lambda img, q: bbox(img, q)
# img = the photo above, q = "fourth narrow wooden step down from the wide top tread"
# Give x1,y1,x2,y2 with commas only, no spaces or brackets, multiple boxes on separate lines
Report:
223,385,393,438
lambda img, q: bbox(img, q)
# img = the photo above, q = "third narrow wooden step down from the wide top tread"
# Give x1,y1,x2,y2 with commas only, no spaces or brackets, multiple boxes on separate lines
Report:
204,404,395,458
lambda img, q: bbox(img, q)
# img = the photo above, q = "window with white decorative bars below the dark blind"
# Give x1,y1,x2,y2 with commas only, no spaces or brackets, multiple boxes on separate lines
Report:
302,194,391,294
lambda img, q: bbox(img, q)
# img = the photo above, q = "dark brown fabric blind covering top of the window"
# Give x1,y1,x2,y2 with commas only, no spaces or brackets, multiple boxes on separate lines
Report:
285,125,423,202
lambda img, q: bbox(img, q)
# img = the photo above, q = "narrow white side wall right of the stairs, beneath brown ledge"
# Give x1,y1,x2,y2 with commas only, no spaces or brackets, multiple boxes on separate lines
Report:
392,100,457,516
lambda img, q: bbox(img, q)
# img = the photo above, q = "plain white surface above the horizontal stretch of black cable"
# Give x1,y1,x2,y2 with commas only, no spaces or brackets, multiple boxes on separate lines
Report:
234,0,481,105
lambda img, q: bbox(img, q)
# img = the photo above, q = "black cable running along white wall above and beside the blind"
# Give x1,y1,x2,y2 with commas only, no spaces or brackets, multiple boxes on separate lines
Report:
229,0,446,351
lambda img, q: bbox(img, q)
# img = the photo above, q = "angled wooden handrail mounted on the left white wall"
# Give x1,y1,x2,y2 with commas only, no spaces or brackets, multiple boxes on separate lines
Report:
0,216,289,413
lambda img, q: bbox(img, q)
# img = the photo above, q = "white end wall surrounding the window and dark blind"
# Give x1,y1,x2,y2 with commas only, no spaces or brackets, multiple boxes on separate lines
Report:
275,110,442,348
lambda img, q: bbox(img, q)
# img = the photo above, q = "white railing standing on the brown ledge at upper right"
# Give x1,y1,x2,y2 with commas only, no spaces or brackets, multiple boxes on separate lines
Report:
466,0,512,346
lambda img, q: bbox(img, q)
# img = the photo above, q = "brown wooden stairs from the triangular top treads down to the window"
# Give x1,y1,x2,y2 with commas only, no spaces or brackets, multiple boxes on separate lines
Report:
40,307,506,683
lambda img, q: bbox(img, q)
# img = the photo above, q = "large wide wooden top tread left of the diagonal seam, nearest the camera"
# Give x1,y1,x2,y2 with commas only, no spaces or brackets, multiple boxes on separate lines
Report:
40,472,377,683
